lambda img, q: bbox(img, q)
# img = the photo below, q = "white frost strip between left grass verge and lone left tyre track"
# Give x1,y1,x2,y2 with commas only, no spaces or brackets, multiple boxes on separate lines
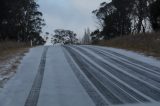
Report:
0,47,43,106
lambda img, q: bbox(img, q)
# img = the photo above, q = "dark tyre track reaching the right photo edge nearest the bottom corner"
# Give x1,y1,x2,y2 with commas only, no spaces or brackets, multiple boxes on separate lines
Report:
74,47,160,101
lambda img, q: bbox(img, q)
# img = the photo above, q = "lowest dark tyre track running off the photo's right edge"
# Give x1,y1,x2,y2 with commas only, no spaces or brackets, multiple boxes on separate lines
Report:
74,47,160,101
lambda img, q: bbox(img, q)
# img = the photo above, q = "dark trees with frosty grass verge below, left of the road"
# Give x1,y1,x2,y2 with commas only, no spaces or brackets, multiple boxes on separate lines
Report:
0,0,45,87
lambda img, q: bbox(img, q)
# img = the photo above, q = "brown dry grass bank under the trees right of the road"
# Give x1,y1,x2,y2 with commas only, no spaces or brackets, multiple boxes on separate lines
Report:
96,33,160,57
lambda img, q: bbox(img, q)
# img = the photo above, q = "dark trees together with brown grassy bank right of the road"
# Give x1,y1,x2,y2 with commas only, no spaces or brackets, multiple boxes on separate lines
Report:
87,0,160,56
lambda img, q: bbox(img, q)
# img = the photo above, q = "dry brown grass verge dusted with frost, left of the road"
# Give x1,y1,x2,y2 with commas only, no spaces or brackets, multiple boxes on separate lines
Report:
0,41,29,87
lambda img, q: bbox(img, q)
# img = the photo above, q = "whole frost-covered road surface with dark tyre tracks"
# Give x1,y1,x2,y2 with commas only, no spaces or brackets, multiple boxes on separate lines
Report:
0,45,160,106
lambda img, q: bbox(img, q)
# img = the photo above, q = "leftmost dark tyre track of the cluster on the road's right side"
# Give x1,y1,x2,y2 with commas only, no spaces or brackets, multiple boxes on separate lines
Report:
63,47,110,106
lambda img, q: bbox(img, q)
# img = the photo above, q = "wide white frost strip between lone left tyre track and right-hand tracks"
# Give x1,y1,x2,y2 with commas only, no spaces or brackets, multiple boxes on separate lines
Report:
37,46,95,106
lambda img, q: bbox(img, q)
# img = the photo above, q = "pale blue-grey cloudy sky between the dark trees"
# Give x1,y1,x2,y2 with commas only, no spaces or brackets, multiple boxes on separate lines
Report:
38,0,110,38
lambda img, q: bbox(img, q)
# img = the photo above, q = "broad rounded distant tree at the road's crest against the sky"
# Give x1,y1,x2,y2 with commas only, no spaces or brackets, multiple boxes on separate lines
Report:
53,29,78,44
